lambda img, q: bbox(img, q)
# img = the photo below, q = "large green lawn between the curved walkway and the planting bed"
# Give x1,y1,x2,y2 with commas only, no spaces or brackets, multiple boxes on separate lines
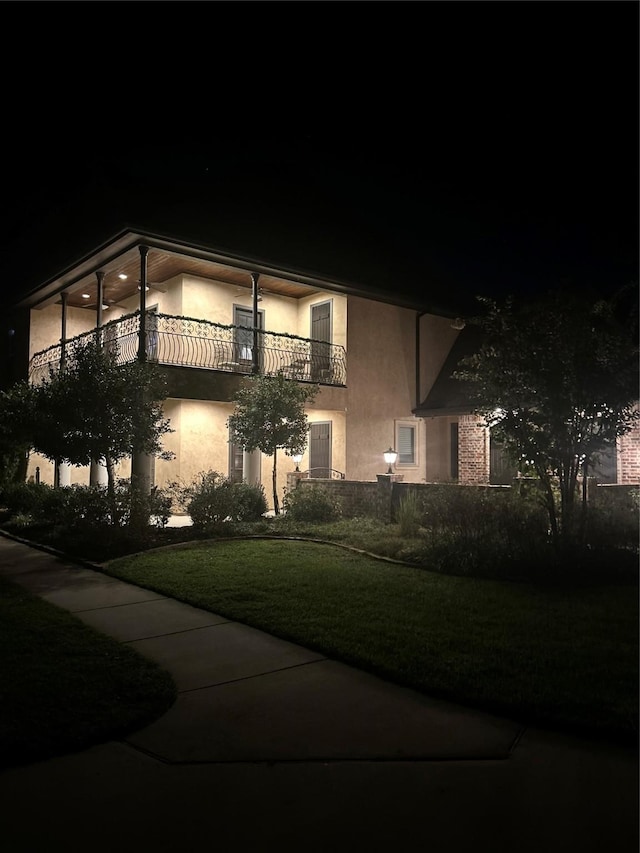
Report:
106,539,638,741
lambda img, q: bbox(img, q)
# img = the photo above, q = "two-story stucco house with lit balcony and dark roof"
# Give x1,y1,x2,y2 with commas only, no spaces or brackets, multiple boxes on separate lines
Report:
7,226,637,506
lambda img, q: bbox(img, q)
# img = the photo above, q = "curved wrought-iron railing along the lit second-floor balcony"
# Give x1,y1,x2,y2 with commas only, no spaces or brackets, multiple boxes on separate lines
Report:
29,312,347,386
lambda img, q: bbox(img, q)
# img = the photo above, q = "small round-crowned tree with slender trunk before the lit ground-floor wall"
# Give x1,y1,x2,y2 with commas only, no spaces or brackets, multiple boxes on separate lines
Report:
228,374,318,515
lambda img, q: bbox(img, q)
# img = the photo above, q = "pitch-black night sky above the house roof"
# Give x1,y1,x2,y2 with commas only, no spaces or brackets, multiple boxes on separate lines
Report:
0,0,638,316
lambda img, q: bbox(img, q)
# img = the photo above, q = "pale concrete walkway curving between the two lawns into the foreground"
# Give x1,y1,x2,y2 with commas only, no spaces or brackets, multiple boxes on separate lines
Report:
0,536,638,853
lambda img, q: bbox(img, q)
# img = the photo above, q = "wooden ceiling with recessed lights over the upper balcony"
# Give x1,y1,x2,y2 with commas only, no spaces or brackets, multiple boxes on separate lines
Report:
34,241,317,309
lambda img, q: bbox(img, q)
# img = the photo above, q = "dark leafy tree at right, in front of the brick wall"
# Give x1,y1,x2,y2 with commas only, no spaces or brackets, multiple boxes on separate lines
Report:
454,292,639,545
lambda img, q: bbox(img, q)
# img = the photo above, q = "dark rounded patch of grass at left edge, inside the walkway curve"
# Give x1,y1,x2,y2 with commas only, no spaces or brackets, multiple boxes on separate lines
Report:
0,578,176,768
